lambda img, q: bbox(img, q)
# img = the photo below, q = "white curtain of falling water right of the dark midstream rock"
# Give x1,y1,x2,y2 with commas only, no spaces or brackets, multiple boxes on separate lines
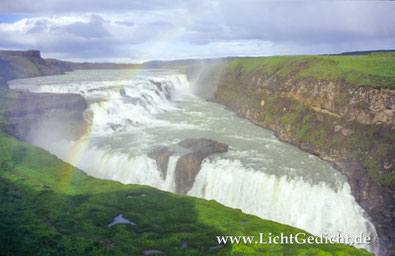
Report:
188,159,378,252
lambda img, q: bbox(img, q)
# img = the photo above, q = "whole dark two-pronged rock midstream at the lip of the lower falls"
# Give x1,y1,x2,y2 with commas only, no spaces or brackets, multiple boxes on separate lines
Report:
148,138,228,194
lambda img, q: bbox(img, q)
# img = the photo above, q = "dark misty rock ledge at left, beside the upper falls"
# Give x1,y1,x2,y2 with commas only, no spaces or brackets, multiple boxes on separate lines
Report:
0,92,88,141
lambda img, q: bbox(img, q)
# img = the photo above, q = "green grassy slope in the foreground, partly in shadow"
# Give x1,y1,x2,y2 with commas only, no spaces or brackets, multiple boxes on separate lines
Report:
0,90,370,256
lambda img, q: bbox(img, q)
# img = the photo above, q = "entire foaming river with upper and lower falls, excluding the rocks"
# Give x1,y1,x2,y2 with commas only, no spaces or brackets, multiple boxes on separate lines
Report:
11,70,378,252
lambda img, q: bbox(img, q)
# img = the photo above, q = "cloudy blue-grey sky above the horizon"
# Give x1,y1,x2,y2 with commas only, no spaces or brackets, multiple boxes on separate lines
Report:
0,0,395,63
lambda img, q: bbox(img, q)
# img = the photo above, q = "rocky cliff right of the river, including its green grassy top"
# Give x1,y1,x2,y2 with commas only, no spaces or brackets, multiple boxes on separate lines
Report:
214,55,395,253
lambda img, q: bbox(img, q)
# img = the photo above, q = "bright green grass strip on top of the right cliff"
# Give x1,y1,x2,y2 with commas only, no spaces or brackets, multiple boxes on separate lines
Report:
229,53,395,88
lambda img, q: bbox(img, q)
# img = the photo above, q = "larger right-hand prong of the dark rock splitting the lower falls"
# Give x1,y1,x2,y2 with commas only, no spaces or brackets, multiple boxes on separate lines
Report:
175,139,228,194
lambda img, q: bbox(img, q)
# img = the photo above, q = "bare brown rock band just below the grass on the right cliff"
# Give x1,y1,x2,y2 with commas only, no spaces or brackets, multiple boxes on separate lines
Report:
281,78,395,129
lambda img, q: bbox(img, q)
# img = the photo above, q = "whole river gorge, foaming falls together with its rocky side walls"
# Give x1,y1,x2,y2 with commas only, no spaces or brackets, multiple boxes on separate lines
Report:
2,50,394,253
